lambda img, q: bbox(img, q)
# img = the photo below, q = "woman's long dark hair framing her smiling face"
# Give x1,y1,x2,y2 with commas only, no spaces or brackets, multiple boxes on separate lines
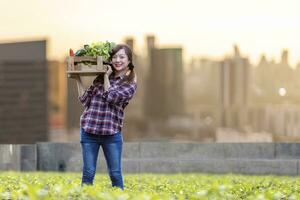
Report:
110,44,136,83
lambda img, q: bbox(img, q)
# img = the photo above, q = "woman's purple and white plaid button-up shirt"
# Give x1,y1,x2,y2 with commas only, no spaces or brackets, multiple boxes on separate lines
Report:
78,76,137,135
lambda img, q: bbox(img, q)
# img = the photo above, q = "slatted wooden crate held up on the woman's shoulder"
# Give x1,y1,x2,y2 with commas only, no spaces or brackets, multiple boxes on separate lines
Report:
67,56,107,78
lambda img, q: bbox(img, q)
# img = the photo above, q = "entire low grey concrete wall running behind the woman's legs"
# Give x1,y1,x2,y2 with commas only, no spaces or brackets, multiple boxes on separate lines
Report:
0,142,300,175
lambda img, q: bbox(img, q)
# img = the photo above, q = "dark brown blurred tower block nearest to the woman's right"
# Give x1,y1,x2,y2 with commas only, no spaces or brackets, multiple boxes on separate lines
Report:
145,40,184,120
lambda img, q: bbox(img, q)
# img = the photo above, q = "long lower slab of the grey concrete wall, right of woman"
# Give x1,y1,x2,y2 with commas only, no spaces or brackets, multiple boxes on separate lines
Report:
140,159,299,175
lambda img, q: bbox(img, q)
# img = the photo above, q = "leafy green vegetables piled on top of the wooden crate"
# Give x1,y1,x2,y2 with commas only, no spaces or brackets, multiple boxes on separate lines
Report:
75,41,116,62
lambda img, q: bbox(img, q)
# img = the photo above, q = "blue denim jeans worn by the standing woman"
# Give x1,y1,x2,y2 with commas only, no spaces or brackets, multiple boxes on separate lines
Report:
80,128,124,190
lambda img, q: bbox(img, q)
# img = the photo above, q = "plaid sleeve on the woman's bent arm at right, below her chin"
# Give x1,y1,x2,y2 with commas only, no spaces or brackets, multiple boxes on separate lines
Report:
102,83,137,104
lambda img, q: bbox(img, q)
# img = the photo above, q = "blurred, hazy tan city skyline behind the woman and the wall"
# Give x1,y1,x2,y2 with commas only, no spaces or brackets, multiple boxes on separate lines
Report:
0,37,300,142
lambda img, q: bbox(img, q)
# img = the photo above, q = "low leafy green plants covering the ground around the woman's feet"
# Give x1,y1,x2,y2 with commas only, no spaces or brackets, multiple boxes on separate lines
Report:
0,172,300,200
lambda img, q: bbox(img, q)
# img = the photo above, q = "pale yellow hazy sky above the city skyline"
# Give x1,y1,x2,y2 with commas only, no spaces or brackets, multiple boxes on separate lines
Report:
0,0,300,65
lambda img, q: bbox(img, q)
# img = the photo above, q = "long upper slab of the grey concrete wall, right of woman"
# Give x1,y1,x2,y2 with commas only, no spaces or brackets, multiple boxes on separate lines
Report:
140,142,275,159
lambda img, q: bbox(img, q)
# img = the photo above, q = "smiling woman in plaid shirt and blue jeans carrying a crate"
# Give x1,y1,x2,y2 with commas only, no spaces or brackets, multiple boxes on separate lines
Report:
76,44,137,190
